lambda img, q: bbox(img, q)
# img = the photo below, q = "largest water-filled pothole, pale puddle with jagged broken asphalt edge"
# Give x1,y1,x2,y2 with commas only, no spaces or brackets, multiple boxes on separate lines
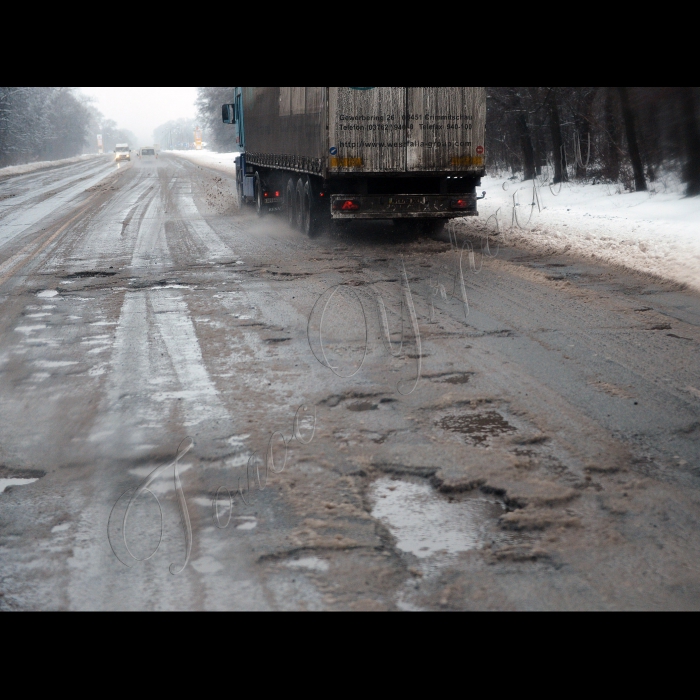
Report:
372,479,512,559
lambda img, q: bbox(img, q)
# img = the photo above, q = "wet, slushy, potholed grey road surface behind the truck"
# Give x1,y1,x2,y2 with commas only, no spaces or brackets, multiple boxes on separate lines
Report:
0,156,700,610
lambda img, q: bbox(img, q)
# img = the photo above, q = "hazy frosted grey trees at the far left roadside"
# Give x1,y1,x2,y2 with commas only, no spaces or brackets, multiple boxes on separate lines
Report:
0,87,91,166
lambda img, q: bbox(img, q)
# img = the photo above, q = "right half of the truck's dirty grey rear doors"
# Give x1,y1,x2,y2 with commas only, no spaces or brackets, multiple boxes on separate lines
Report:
406,87,486,172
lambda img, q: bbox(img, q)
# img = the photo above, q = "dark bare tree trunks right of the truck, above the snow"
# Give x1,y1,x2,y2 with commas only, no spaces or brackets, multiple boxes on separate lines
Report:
487,87,700,195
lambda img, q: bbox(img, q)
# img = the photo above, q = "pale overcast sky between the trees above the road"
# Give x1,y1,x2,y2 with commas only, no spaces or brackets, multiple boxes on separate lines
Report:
80,88,197,146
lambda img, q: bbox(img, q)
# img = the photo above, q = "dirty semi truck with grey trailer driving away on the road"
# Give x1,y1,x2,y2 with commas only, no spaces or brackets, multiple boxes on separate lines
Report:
222,87,486,236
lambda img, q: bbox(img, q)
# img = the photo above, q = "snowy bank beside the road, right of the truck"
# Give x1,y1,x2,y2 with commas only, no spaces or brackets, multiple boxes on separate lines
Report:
466,177,700,290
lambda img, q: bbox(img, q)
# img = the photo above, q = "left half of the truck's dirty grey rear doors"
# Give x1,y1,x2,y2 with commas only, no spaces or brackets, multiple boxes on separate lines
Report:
329,87,408,173
